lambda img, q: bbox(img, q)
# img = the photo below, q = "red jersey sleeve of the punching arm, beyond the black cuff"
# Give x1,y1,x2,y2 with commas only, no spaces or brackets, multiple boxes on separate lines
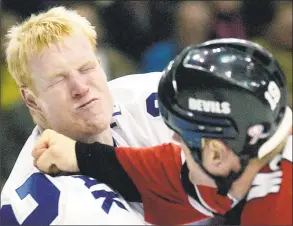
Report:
115,143,207,225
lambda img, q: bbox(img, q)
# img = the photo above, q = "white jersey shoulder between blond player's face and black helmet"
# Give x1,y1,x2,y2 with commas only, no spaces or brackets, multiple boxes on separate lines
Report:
110,72,173,147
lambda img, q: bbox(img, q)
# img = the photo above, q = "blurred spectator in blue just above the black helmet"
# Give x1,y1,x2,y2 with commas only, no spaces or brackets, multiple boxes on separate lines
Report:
141,1,213,72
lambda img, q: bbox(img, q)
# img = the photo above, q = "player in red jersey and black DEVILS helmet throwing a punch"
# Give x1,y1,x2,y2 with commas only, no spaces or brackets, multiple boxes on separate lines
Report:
33,39,292,225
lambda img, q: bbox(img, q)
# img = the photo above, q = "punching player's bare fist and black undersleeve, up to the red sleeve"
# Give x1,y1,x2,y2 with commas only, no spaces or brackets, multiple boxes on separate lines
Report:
32,129,140,201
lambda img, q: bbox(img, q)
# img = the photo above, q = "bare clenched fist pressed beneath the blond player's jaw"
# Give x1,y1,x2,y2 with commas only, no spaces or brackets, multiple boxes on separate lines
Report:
32,129,79,174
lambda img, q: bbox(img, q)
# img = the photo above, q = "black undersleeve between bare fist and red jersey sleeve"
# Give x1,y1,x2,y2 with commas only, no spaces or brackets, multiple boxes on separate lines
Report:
75,142,141,201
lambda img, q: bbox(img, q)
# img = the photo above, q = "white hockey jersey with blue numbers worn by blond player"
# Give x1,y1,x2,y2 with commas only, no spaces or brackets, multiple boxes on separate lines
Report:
0,73,172,225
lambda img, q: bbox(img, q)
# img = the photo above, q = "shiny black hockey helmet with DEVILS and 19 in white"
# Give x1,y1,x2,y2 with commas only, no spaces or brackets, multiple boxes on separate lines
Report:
158,38,292,195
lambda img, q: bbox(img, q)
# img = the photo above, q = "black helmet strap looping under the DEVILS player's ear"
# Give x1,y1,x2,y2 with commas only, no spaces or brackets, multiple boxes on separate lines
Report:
189,147,249,196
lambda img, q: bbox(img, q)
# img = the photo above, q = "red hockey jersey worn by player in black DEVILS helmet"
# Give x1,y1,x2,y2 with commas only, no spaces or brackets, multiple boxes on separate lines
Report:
116,136,292,225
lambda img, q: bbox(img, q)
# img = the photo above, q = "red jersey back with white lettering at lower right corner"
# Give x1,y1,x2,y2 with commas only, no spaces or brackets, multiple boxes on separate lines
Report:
241,136,293,225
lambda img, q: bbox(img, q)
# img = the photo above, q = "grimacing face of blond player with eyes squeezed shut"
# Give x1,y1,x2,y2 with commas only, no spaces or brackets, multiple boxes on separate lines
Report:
29,35,113,142
